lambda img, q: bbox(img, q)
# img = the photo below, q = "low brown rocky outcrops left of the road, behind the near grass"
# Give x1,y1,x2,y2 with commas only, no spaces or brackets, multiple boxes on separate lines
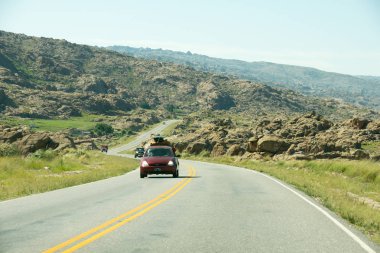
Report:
0,110,163,156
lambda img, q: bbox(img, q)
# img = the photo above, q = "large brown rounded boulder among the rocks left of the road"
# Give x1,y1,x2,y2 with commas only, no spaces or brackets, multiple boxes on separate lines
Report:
18,133,59,155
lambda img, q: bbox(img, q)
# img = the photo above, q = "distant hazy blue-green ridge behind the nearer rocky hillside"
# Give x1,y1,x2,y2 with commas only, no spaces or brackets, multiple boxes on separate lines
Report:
108,46,380,109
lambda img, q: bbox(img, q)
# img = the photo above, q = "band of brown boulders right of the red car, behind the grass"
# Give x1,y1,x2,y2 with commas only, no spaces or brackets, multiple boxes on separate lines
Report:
171,112,380,160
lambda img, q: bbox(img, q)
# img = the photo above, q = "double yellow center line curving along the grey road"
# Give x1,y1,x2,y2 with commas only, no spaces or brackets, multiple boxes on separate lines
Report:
43,167,195,253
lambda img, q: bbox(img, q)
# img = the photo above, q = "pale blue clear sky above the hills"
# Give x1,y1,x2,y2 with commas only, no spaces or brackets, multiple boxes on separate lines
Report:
0,0,380,76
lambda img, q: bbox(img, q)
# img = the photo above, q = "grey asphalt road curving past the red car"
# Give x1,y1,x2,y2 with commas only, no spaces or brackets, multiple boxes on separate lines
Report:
0,121,380,253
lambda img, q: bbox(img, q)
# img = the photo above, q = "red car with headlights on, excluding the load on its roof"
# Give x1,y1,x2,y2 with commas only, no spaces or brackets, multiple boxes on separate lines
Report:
140,146,179,178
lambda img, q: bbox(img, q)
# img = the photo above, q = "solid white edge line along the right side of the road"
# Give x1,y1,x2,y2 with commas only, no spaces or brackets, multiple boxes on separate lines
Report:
251,170,376,253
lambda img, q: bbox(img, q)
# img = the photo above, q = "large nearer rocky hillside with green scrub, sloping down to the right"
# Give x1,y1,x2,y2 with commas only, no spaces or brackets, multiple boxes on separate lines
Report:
0,31,376,118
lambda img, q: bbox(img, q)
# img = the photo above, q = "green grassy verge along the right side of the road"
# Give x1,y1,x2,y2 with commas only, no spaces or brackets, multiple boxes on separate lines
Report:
183,154,380,244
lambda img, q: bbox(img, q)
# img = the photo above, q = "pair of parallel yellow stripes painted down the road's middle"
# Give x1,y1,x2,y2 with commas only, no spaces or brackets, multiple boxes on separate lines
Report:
43,168,195,253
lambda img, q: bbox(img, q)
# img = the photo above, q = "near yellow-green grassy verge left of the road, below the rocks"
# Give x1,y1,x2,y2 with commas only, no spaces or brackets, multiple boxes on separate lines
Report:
0,150,138,200
